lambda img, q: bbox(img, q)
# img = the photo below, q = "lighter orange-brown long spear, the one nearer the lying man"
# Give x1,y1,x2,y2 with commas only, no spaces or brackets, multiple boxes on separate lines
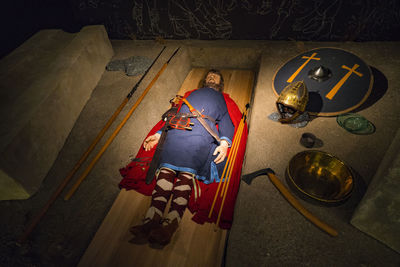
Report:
64,48,179,200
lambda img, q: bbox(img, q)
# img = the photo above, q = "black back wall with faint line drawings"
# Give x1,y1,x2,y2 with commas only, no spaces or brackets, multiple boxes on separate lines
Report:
0,0,400,57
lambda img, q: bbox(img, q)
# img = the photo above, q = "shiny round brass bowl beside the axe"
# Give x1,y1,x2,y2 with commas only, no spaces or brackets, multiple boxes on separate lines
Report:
286,150,354,203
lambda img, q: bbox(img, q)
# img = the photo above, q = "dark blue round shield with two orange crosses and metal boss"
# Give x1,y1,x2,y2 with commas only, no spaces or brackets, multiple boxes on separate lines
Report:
272,48,373,116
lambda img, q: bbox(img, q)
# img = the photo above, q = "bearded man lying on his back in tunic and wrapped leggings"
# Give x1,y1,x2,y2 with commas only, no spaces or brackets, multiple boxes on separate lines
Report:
120,70,244,246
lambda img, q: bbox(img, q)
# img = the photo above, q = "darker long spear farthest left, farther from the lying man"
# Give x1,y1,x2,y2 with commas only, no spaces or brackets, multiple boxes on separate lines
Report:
17,46,166,244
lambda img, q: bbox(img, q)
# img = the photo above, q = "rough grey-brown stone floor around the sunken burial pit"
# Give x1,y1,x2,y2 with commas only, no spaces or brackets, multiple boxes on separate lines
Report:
0,38,400,266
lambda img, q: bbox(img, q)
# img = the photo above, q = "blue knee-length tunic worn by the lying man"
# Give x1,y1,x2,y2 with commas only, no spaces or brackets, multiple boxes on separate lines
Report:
160,88,234,183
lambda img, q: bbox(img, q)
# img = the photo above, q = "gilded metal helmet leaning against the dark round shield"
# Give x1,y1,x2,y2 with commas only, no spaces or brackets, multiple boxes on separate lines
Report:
276,81,308,123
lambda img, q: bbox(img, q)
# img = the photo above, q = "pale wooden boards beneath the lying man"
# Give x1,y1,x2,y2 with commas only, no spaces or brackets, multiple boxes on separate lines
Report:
78,68,254,267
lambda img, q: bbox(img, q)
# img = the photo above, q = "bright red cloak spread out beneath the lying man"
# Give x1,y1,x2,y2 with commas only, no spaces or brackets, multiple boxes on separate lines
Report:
119,91,248,229
